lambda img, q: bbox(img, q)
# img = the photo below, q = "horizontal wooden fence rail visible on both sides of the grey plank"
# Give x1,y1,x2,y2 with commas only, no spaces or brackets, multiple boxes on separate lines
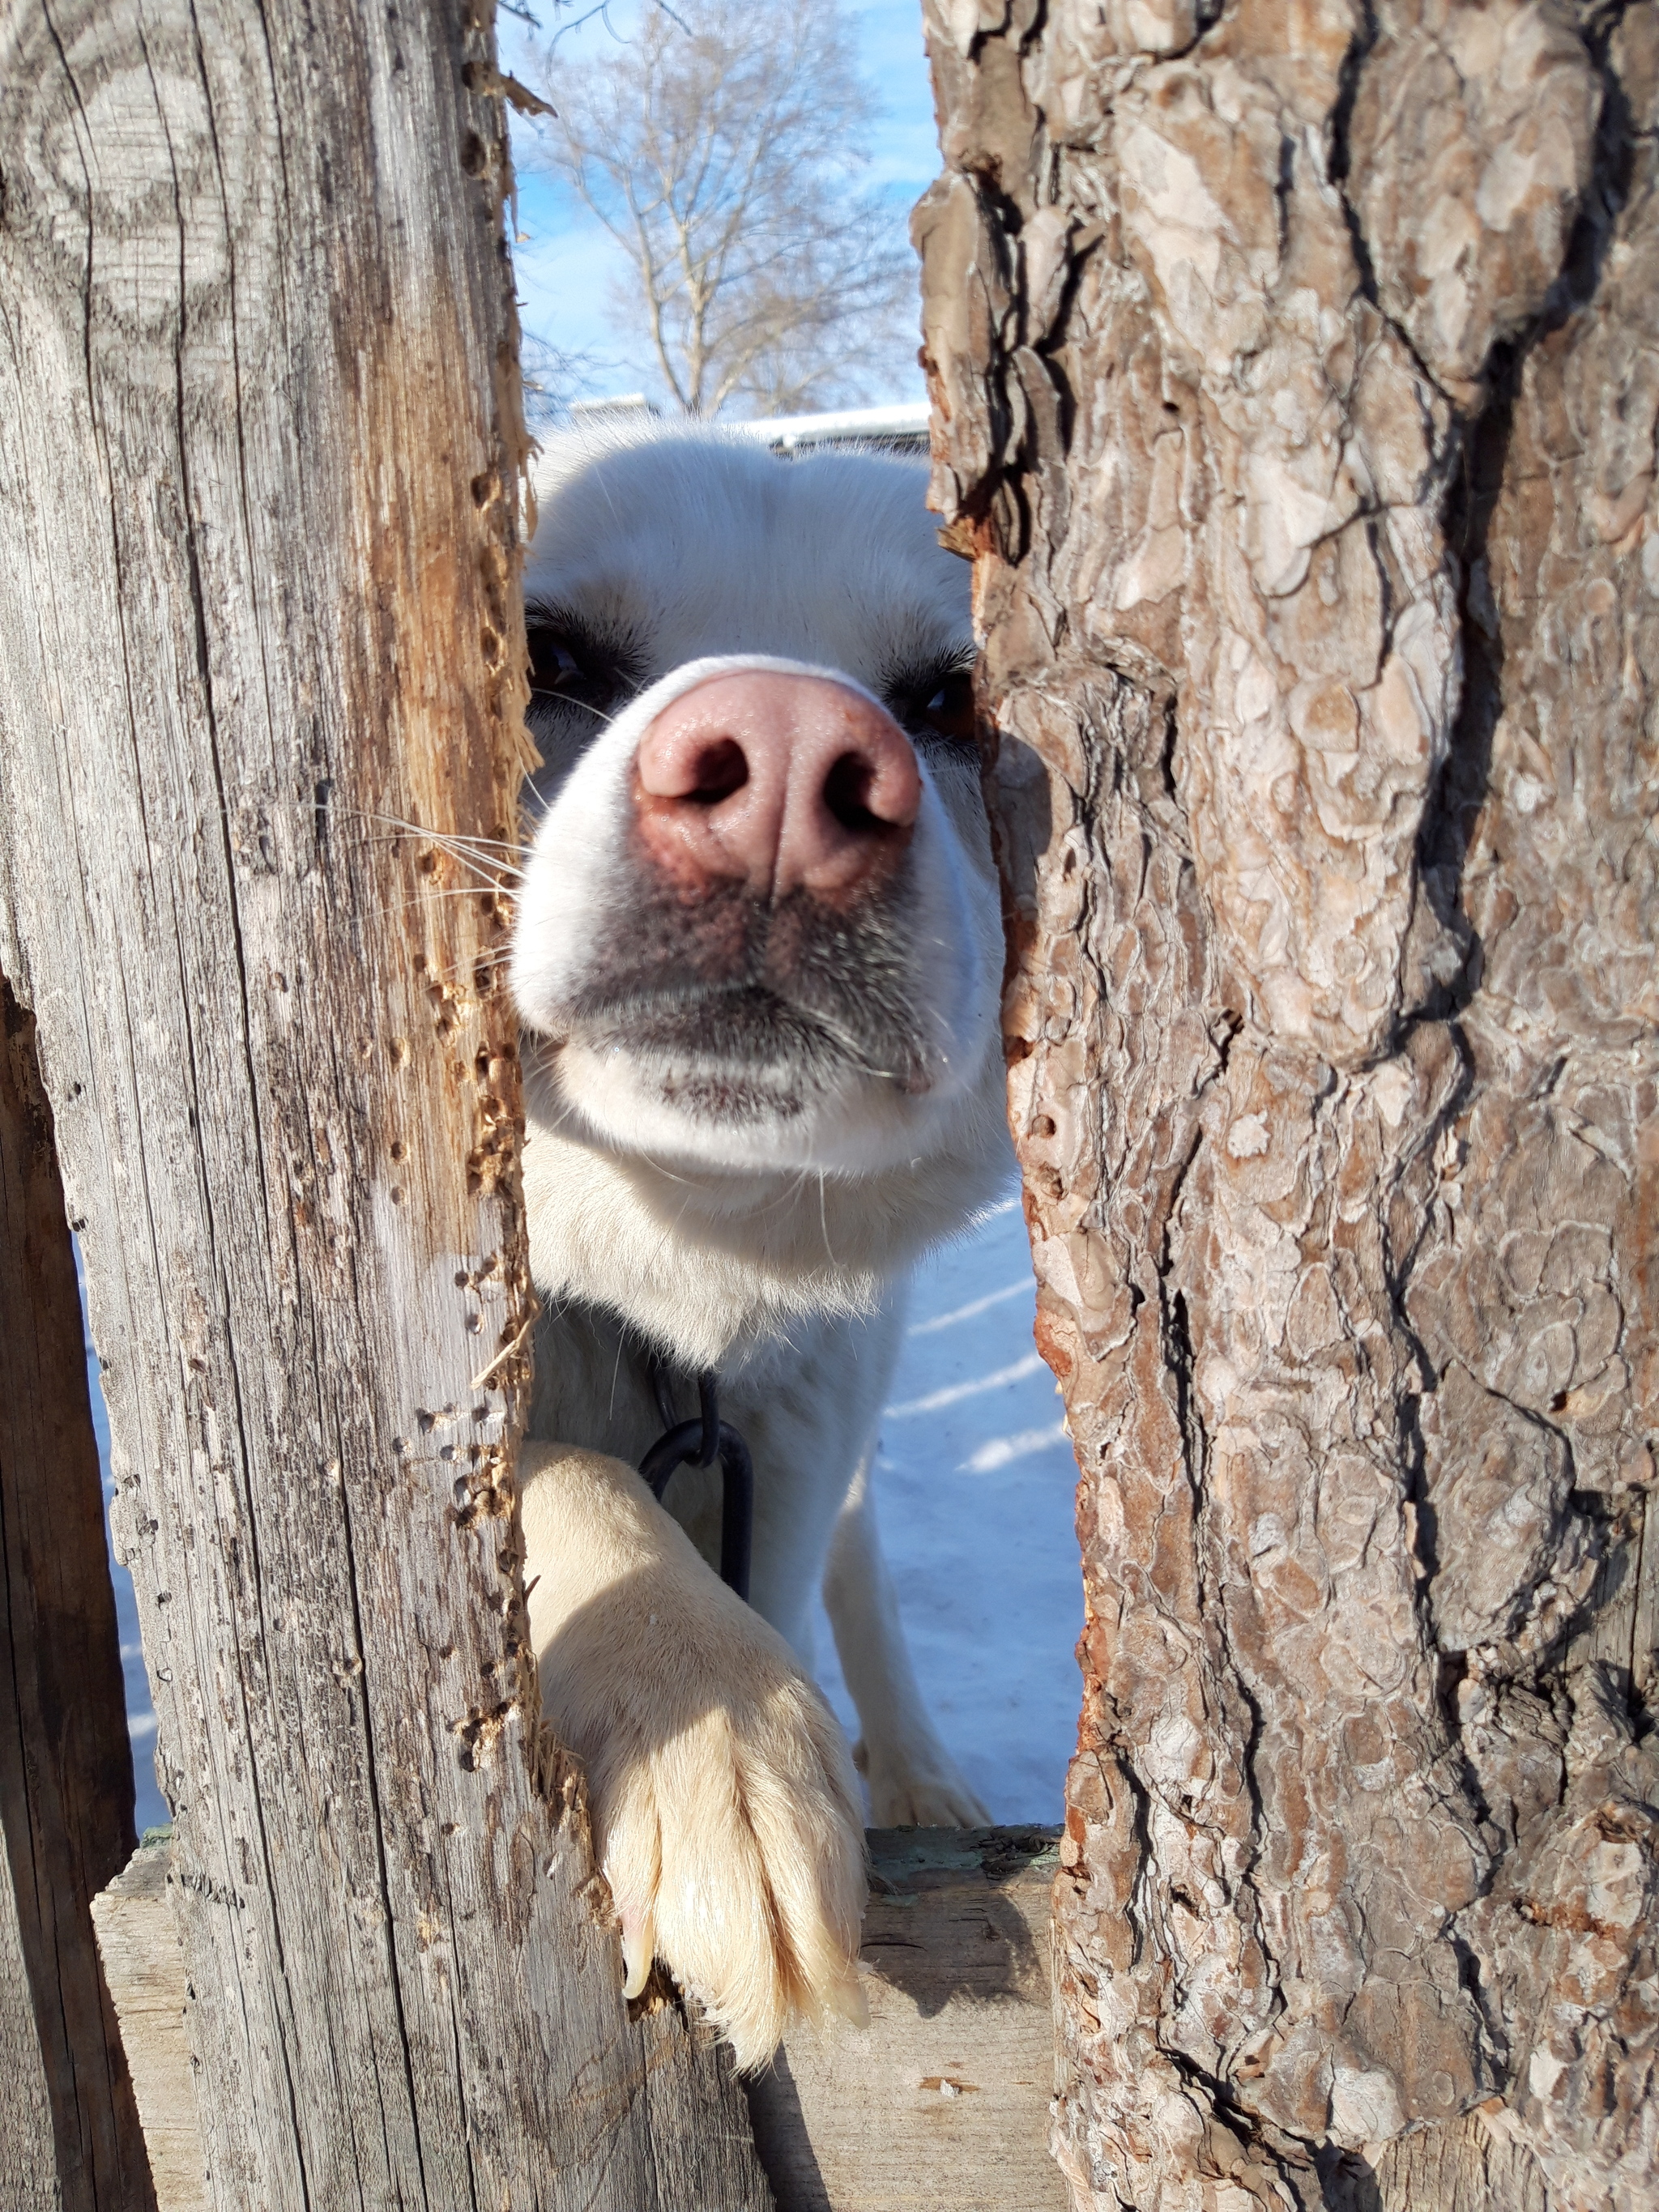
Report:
93,1827,1064,2212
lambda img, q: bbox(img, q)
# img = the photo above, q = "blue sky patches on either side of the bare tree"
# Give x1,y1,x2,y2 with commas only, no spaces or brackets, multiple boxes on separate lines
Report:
497,0,938,413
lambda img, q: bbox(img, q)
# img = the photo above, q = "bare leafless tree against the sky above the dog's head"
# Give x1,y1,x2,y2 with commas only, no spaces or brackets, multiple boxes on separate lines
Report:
526,0,915,416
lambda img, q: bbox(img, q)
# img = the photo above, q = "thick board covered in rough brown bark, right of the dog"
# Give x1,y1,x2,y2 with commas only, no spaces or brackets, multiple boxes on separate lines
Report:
918,0,1659,2212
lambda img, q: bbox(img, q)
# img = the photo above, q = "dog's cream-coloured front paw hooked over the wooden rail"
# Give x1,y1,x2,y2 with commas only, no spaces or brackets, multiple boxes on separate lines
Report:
522,1444,865,2068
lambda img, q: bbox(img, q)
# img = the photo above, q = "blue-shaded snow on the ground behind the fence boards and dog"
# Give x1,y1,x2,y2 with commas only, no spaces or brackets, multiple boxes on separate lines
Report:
86,1199,1081,1831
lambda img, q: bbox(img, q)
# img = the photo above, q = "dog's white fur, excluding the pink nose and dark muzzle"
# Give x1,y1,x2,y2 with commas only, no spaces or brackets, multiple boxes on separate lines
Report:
514,429,1006,2066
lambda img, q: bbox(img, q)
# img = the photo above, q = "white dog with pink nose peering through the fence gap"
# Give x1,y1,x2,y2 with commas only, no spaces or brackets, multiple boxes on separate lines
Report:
514,429,1006,2066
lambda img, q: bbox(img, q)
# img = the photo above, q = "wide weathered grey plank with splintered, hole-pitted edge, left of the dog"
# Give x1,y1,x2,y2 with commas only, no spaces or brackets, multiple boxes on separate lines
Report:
0,0,768,2212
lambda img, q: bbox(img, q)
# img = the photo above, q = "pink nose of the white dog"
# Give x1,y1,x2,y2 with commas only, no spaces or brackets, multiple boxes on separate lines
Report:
635,668,923,898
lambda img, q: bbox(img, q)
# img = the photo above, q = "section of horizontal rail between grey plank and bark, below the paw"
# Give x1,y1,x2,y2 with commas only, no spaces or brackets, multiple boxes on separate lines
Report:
750,1827,1064,2212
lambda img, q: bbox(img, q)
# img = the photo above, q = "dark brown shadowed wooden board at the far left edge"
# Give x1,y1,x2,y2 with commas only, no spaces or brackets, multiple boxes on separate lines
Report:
0,975,151,2212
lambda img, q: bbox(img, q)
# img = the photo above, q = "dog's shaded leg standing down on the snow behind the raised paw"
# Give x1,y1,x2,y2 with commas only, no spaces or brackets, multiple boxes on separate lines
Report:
823,1444,991,1827
